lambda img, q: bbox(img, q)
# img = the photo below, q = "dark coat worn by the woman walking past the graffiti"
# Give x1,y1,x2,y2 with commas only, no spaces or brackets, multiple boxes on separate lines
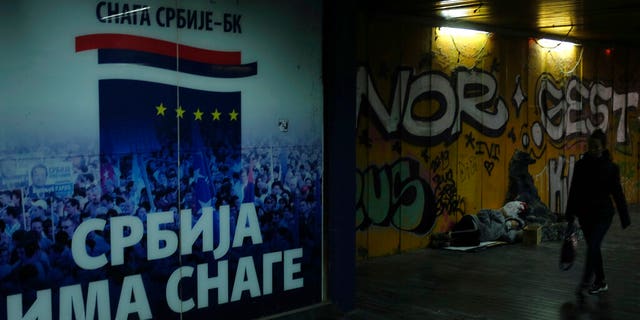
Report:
566,150,631,228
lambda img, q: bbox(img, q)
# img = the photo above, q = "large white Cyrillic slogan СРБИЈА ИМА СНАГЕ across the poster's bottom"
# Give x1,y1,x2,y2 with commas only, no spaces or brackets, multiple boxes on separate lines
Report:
6,203,304,320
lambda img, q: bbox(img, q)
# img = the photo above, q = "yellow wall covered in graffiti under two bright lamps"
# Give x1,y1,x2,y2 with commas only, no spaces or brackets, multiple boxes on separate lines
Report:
355,17,640,258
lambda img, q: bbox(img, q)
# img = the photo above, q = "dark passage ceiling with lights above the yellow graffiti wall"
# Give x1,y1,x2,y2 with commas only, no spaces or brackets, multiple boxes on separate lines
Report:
358,0,640,47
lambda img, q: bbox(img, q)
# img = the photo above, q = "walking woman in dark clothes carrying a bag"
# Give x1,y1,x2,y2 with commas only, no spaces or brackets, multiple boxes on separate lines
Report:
566,129,631,294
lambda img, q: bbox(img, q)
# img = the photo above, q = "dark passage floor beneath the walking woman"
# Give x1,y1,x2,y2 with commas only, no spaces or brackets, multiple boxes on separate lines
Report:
344,208,640,320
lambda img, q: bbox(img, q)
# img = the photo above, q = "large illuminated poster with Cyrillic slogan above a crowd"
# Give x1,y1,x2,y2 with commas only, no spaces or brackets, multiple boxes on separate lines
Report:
0,0,324,319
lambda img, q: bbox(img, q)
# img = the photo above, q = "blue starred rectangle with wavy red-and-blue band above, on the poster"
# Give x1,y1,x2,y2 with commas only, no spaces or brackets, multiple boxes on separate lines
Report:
75,33,250,212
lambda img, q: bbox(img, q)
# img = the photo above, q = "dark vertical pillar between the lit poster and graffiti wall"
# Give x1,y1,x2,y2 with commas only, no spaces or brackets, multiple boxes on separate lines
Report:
323,0,356,311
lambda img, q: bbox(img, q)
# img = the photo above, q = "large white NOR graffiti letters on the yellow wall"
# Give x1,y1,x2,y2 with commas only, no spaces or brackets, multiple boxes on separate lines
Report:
356,67,509,145
